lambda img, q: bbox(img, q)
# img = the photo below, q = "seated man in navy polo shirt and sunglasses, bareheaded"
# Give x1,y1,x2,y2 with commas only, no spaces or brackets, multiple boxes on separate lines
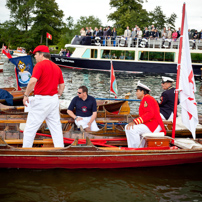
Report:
67,86,99,131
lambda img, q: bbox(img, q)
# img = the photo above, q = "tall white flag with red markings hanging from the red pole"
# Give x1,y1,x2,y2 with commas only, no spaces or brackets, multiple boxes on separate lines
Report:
180,6,198,139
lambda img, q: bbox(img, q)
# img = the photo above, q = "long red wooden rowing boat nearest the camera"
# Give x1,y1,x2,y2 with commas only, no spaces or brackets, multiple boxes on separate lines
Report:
0,137,202,169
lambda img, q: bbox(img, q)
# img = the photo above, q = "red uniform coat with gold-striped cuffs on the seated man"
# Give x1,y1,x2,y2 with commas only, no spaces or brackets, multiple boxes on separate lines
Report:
134,94,166,134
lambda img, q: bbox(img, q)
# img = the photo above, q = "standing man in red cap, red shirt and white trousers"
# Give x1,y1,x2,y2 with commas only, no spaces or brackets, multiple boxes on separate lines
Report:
23,45,65,147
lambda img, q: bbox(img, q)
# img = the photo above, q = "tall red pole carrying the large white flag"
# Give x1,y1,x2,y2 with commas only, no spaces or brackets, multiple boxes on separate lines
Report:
172,3,187,143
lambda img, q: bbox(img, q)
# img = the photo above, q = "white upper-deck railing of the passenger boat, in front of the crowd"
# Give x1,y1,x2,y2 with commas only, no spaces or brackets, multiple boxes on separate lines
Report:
71,35,202,50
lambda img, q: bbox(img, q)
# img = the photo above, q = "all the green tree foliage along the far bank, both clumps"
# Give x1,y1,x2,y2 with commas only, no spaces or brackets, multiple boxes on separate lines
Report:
0,0,177,52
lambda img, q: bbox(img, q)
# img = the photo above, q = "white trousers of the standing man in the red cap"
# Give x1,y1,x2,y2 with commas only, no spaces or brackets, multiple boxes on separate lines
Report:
23,94,64,147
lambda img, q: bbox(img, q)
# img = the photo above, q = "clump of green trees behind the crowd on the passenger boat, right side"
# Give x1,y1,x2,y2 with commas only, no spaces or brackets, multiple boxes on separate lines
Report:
108,0,177,35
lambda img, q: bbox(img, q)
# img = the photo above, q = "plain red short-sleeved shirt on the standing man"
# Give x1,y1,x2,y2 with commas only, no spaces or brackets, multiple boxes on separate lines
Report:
32,60,64,96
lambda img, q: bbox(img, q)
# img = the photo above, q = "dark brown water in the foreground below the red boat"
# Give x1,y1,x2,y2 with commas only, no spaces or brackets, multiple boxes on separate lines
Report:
0,164,202,202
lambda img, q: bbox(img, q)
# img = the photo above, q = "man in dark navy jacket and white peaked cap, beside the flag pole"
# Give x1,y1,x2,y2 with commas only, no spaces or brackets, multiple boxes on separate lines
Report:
159,76,179,120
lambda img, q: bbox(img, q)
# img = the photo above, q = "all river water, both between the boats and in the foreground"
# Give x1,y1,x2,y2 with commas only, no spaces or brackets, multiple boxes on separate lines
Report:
0,59,202,202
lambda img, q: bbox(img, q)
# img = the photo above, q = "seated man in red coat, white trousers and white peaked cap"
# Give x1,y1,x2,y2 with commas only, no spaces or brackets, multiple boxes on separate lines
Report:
125,81,166,148
